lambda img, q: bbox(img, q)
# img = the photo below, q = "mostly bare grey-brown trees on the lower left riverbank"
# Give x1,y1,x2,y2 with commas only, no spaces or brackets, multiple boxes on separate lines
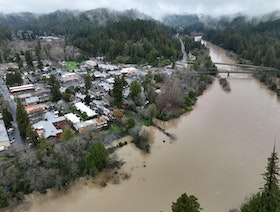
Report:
0,133,121,207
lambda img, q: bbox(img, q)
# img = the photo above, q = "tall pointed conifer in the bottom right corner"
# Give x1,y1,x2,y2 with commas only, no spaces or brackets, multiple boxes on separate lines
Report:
241,146,280,212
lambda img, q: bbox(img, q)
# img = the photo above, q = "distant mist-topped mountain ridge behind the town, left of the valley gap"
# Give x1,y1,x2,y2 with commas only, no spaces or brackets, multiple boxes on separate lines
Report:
0,8,152,35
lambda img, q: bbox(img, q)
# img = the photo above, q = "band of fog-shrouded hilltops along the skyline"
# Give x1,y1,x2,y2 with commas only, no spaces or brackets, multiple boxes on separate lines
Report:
0,8,280,34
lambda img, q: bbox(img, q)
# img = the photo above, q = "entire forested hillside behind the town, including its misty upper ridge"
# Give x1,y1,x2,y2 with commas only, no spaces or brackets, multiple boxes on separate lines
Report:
0,9,181,66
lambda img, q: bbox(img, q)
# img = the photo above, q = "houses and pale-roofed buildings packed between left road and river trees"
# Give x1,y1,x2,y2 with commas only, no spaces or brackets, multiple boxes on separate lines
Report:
0,59,162,141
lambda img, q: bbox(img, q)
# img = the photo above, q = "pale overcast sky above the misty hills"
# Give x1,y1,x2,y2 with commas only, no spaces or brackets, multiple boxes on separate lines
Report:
0,0,280,18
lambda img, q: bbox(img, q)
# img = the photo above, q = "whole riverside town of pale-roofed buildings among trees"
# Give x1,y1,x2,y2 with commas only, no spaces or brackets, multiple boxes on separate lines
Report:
0,32,208,150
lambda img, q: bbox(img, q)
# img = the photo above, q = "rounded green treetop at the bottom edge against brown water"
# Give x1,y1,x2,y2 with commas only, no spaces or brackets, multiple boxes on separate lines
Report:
171,193,202,212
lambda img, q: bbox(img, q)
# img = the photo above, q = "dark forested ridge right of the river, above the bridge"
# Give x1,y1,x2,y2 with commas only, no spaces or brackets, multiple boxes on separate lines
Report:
206,17,280,69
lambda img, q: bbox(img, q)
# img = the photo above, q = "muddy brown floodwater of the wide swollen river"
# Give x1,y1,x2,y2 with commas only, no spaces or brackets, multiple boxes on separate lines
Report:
20,42,280,212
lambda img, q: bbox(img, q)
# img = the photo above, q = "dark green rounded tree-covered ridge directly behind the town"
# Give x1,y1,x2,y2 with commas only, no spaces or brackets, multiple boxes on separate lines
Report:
70,19,181,65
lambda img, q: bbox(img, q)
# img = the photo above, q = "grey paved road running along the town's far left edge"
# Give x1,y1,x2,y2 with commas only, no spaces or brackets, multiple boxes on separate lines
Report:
0,78,25,145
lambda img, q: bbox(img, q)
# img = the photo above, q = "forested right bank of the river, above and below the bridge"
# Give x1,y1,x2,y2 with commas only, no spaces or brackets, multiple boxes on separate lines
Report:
192,14,280,96
